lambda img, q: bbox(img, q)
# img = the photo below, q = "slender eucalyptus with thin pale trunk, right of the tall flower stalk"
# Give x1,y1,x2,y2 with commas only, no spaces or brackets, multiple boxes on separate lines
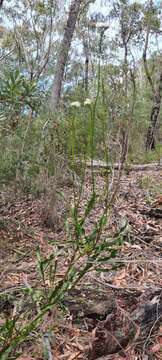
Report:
110,0,142,157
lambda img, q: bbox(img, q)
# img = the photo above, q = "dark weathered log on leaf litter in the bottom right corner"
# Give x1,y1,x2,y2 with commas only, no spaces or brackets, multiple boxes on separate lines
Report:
88,290,162,360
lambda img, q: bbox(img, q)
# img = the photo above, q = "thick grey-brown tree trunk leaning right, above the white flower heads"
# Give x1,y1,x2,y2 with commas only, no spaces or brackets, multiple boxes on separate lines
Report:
50,0,83,111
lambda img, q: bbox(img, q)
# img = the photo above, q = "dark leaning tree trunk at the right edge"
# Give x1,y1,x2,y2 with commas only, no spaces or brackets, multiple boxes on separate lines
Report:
146,73,162,150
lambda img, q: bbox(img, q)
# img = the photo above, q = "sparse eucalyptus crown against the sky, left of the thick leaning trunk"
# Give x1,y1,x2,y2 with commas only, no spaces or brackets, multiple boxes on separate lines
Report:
1,0,57,79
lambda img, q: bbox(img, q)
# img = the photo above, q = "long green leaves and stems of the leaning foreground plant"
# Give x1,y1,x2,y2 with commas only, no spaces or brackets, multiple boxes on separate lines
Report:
0,191,122,360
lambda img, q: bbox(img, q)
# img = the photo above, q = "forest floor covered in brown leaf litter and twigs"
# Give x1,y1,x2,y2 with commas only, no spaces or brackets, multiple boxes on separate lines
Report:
0,170,162,360
